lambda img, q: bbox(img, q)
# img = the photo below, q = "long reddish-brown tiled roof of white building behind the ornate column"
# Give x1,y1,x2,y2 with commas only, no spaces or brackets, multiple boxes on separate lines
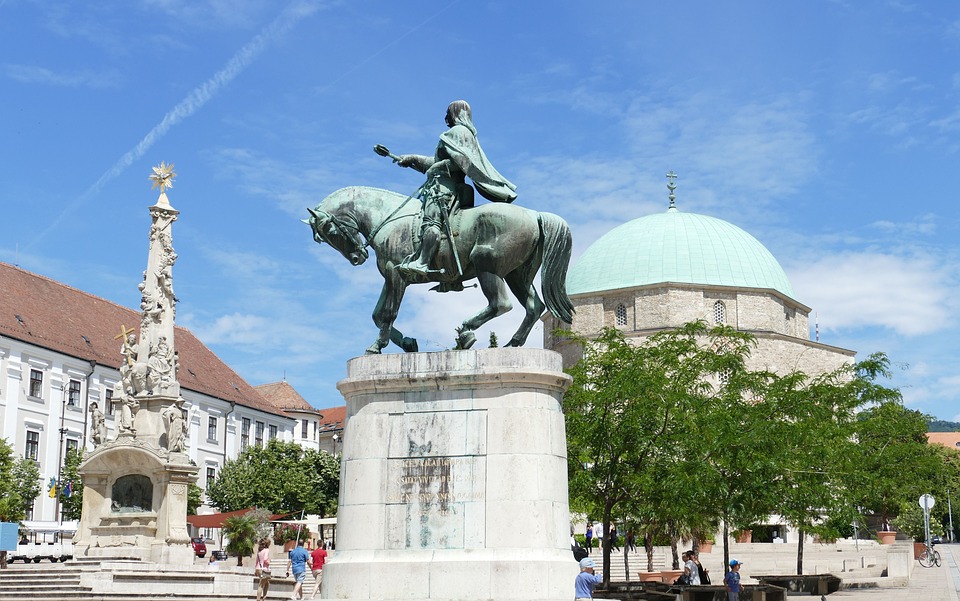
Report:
0,263,286,417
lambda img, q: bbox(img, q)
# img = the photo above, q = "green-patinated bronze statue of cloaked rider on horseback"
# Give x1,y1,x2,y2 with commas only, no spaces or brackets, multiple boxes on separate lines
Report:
304,100,574,353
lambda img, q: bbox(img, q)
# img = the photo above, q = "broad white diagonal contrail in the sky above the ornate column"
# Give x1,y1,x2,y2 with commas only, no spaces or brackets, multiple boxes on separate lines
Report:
24,0,320,250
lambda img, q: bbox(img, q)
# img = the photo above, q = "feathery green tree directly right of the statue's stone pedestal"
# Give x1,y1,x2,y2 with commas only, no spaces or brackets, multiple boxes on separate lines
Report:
563,322,754,581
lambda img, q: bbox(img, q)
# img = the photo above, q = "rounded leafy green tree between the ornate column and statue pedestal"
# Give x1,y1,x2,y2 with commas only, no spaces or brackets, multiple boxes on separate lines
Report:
207,439,340,516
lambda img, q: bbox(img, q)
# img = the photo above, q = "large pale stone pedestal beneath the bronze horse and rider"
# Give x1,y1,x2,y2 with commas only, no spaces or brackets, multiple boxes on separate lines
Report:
323,348,579,601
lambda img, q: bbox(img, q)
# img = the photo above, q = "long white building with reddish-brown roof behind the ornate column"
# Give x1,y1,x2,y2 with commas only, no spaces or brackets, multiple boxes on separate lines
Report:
0,263,299,521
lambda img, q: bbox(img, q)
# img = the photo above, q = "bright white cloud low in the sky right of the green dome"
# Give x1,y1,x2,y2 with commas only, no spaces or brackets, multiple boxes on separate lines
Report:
790,252,955,336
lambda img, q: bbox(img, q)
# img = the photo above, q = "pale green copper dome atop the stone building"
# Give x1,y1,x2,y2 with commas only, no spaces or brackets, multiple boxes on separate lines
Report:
567,207,793,298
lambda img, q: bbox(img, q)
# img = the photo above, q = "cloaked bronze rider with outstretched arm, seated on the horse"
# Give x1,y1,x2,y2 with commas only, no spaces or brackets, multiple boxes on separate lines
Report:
397,100,517,282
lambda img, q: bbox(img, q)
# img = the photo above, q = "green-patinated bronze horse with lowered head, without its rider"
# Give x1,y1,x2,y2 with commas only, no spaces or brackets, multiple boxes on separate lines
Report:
304,186,574,354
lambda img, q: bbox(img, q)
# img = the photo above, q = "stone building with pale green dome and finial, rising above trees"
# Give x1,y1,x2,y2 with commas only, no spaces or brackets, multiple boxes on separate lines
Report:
544,176,855,374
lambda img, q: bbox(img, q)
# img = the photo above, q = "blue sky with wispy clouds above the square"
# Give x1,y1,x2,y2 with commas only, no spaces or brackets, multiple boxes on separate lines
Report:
0,0,960,420
